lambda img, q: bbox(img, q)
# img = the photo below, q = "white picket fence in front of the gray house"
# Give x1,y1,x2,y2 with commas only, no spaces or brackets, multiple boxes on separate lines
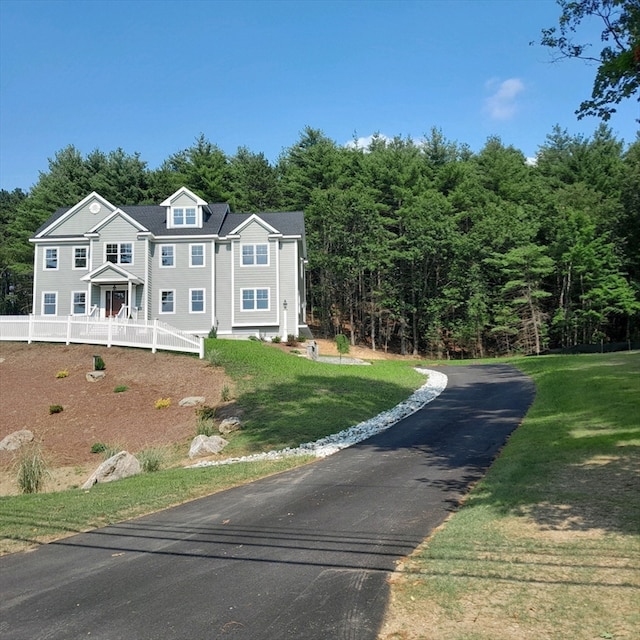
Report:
0,315,204,358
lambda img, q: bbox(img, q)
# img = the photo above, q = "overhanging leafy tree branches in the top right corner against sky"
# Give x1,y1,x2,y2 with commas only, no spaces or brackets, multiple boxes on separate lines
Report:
540,0,640,121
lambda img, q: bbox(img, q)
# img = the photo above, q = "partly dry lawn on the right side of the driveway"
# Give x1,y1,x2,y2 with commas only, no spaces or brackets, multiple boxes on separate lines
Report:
381,353,640,640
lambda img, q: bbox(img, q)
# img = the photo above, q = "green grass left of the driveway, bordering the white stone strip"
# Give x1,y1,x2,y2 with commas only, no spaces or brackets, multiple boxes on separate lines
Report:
0,340,424,553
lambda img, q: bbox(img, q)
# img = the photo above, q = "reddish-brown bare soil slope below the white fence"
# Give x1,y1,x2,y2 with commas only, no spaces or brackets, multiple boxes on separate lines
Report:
0,340,395,495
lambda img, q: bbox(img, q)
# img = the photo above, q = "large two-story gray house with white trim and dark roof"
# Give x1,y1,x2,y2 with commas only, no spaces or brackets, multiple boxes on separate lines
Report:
30,187,308,338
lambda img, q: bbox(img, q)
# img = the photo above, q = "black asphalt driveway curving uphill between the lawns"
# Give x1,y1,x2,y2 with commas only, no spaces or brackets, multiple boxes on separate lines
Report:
0,365,535,640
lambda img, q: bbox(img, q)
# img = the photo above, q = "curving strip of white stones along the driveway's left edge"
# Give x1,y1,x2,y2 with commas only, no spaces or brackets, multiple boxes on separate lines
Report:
188,368,447,469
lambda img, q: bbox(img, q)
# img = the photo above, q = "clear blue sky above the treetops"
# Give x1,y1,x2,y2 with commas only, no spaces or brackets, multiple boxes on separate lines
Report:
0,0,640,190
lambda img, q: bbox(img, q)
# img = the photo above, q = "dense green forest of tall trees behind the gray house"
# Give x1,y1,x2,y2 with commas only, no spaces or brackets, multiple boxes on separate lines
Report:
0,123,640,358
